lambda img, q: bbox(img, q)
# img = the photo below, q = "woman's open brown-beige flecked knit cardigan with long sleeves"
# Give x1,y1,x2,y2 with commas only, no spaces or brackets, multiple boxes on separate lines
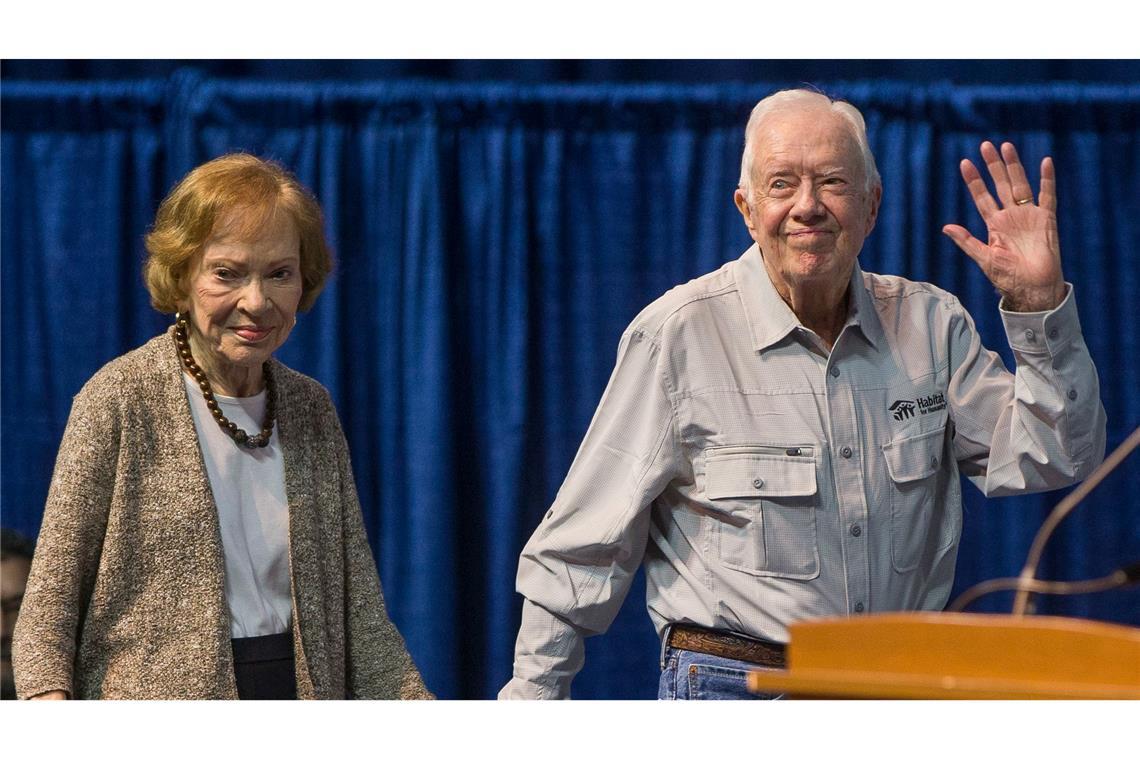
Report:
13,329,431,700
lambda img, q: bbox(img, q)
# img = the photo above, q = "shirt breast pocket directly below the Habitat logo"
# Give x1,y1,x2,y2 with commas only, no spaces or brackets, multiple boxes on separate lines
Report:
882,427,954,572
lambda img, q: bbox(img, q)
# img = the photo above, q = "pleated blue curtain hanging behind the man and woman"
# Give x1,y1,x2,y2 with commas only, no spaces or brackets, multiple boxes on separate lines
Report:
0,70,1140,698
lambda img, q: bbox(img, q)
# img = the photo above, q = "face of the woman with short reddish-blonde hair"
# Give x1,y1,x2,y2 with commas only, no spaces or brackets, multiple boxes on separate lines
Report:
182,214,302,382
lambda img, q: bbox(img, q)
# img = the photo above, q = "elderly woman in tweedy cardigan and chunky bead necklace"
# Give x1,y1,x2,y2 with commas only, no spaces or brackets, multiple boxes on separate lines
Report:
15,155,431,698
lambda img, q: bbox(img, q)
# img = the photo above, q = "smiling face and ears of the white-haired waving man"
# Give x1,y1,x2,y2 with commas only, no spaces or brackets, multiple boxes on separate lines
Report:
735,108,881,294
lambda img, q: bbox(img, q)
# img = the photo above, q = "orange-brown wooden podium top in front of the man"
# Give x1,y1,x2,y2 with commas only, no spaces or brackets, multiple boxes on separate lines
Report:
748,612,1140,700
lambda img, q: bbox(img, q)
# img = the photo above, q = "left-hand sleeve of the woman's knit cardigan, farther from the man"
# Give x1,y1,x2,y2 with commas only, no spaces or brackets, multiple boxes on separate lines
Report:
13,371,122,698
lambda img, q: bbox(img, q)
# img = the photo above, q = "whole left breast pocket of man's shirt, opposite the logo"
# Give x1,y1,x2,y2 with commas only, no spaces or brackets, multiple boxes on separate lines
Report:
705,446,820,580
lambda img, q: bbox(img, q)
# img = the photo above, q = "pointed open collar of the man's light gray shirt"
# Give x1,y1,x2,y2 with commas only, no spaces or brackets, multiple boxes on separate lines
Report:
735,244,882,351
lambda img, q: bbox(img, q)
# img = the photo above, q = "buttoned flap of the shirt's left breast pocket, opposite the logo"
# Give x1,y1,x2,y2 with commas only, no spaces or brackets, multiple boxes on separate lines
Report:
705,448,815,499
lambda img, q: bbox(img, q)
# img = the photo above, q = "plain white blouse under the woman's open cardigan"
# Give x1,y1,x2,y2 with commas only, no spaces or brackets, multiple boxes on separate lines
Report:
182,373,293,638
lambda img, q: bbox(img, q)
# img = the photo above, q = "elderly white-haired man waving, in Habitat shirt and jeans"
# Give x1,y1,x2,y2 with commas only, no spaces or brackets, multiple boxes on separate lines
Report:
499,90,1105,698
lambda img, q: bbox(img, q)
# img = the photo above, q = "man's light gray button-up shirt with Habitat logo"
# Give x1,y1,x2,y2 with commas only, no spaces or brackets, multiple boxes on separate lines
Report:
499,245,1105,698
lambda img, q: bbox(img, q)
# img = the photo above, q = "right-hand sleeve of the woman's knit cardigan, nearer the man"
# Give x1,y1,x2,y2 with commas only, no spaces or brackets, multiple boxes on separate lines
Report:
336,417,435,700
